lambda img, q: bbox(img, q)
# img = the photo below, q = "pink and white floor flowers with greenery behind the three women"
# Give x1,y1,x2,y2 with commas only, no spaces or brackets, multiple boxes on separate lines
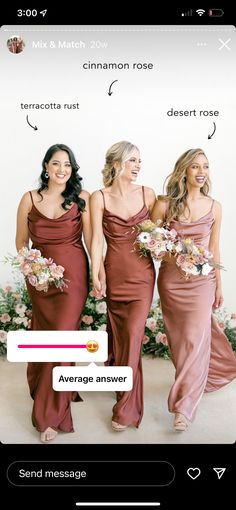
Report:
0,281,236,359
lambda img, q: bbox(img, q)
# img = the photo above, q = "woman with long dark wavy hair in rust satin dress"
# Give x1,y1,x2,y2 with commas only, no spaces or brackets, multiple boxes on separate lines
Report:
16,144,91,442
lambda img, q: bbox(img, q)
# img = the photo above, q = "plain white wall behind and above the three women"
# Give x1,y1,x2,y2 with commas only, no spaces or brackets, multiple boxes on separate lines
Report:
0,26,236,312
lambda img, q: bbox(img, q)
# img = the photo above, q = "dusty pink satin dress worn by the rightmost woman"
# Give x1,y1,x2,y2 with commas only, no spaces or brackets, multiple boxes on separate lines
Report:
158,201,236,421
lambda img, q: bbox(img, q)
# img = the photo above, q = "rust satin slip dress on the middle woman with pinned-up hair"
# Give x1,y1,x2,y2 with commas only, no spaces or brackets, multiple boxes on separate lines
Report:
101,187,155,427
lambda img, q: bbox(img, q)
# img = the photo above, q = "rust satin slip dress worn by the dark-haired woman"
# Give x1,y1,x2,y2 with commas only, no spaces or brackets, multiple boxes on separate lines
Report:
27,193,89,432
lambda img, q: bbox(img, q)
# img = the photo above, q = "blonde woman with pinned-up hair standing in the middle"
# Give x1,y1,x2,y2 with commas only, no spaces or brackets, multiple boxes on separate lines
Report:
91,141,155,432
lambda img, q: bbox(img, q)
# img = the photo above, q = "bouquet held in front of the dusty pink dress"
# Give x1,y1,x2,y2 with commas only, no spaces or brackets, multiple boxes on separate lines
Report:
135,220,223,279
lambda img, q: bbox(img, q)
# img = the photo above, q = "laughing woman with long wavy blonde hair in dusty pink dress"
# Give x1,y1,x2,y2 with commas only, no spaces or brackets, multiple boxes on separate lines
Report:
152,149,236,431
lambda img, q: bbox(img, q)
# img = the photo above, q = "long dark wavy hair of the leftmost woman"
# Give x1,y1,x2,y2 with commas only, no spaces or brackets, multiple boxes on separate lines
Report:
37,143,86,212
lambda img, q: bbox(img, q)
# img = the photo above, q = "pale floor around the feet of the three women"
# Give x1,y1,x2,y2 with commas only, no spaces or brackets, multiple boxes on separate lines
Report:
0,357,236,444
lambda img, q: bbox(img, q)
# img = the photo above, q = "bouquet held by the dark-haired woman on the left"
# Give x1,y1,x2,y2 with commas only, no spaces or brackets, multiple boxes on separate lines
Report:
5,247,67,292
